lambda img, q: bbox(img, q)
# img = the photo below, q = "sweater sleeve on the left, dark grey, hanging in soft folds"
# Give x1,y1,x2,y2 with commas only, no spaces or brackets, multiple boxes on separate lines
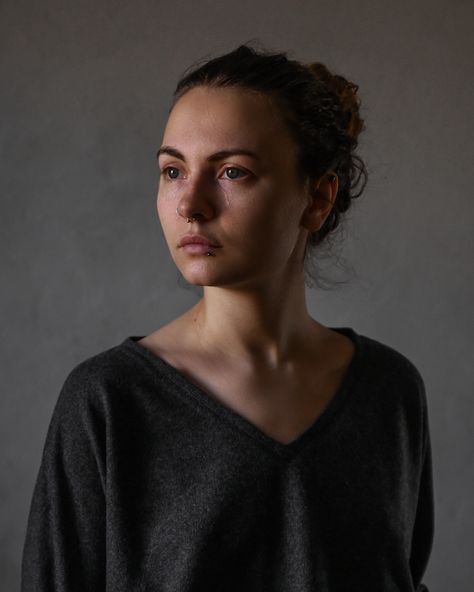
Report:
21,368,105,592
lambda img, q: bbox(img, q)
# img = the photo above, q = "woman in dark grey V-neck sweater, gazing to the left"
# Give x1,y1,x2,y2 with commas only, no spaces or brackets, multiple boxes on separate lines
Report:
22,46,433,592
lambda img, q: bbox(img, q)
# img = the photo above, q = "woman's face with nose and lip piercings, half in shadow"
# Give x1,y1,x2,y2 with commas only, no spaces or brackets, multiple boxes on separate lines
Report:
157,87,316,287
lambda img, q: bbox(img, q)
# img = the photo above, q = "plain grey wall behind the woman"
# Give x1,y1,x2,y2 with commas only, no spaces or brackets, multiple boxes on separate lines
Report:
0,0,474,592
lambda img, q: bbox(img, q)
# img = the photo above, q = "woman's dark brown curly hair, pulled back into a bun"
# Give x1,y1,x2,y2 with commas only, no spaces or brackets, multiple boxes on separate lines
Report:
173,45,367,288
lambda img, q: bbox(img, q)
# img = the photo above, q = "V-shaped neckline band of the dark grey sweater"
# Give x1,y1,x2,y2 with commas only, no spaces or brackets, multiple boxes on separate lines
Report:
120,327,363,458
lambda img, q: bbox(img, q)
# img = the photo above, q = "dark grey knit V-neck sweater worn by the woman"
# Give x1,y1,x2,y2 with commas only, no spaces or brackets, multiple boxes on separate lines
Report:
21,327,434,592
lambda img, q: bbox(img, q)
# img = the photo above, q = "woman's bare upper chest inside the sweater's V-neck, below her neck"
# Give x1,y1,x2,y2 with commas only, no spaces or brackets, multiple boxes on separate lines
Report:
135,330,354,444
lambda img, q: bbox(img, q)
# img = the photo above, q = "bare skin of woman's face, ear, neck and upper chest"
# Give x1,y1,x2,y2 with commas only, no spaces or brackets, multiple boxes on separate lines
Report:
141,87,353,441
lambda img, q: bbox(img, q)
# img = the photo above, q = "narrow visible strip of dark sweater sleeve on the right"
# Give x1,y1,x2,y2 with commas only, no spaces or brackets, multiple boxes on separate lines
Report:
410,377,434,592
